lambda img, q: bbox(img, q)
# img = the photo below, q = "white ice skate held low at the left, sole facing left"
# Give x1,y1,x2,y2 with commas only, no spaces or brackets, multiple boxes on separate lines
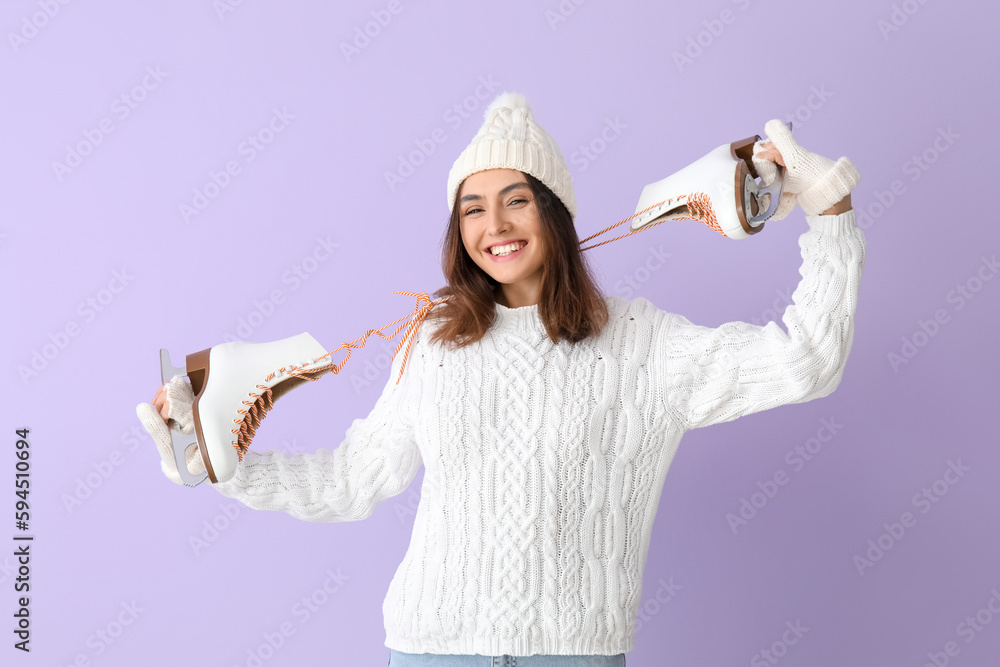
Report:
160,333,333,486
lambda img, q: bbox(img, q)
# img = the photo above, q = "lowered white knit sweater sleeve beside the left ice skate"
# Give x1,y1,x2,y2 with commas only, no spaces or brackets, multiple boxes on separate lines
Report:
213,340,423,522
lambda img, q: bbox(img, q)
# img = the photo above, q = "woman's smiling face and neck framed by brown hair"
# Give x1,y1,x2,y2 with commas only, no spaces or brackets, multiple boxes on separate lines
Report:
455,169,546,308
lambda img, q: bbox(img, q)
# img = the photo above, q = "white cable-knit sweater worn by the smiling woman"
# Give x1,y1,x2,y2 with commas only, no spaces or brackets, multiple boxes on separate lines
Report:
215,211,865,656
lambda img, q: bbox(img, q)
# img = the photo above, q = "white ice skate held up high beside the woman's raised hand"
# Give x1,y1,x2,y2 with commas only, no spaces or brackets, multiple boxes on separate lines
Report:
631,123,791,239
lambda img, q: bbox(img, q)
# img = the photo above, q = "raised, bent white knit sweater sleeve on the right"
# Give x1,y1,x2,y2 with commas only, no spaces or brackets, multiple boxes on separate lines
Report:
654,209,865,430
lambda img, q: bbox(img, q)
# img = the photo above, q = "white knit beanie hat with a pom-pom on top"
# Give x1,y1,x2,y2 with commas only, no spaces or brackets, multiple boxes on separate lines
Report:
448,92,576,219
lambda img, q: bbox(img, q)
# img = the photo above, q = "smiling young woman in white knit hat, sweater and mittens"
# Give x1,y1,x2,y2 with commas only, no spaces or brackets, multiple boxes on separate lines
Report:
140,93,864,667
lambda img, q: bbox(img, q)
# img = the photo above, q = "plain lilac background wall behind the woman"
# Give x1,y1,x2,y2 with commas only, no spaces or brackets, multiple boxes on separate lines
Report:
0,0,1000,667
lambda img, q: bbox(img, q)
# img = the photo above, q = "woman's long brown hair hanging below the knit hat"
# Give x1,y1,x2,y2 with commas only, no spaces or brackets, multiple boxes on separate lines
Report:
427,172,608,348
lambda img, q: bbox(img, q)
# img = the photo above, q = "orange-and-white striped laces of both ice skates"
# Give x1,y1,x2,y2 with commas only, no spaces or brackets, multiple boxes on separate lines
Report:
232,192,725,461
